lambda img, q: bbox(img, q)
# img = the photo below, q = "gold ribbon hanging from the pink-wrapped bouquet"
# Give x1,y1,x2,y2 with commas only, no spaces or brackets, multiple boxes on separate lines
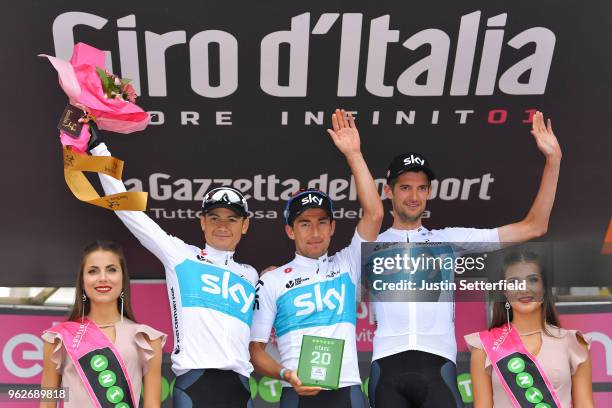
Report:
64,147,147,211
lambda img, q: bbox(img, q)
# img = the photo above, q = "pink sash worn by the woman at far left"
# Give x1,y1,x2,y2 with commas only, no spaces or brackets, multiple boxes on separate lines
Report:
46,319,138,408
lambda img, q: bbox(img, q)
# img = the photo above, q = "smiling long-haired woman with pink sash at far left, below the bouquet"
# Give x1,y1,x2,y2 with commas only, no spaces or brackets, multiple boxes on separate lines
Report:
41,241,166,408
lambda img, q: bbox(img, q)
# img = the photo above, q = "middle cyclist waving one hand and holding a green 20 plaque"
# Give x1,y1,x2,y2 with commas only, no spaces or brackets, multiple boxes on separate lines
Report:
250,110,383,408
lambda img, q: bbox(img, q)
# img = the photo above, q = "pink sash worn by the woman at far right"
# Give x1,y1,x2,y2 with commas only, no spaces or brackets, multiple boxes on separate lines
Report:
478,325,562,408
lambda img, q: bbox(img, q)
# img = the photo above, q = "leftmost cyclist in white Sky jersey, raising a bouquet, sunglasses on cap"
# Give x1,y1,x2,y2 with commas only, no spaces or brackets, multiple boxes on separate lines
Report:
90,139,258,408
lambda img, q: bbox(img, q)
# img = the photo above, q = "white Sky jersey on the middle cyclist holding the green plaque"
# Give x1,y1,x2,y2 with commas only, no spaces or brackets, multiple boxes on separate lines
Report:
251,232,363,387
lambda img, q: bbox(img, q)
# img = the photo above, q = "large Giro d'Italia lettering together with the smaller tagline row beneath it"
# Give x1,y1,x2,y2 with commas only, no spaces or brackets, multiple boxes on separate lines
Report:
52,10,556,126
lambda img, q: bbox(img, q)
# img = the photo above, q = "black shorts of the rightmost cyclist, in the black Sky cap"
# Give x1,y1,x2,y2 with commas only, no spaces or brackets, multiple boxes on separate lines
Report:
368,350,464,408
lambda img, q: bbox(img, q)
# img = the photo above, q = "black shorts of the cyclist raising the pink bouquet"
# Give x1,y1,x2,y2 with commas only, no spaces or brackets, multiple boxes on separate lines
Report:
172,368,253,408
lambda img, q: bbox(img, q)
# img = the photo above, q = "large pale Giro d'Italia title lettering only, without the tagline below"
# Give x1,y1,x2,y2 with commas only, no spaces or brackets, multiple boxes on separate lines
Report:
52,11,556,98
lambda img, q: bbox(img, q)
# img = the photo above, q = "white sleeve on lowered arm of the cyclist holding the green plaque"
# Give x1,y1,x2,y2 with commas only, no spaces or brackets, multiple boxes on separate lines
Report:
251,271,277,343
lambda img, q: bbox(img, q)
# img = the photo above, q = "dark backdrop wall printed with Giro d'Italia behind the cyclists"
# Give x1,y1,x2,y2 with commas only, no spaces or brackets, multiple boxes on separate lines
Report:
0,0,612,406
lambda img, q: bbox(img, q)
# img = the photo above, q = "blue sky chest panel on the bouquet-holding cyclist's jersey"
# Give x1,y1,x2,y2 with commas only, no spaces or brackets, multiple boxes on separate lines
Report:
176,259,255,326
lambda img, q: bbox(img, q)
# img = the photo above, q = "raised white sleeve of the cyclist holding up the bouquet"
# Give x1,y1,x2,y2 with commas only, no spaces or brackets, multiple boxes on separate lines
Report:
91,143,187,265
